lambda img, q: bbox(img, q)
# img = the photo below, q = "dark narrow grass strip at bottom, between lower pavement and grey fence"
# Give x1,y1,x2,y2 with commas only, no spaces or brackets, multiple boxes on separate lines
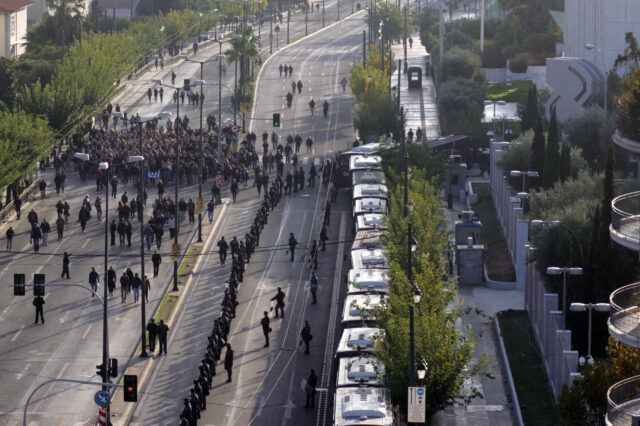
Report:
498,310,560,425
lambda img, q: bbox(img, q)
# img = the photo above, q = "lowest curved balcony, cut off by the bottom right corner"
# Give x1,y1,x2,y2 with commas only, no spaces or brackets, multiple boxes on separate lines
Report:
605,376,640,426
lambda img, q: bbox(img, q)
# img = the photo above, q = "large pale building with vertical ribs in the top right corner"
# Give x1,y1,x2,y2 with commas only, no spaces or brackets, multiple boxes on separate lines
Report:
564,0,640,73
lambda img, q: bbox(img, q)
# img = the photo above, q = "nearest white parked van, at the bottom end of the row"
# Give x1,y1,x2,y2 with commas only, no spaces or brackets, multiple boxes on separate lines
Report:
333,387,393,426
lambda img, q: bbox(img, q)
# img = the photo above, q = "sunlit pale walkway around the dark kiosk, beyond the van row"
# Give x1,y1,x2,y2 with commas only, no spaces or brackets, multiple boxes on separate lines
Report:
391,33,440,141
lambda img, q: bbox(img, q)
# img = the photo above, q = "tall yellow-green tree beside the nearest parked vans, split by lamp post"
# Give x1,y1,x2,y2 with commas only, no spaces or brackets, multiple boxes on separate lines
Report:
375,169,486,417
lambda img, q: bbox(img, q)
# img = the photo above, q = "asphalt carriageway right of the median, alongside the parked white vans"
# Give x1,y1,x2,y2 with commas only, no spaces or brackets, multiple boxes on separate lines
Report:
132,14,365,425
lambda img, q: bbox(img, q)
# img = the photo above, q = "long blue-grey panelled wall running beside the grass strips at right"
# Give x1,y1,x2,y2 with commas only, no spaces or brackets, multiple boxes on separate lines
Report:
490,142,578,400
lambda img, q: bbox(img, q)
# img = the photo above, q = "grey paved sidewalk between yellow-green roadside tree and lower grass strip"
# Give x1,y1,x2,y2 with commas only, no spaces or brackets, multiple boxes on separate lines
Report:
436,201,524,426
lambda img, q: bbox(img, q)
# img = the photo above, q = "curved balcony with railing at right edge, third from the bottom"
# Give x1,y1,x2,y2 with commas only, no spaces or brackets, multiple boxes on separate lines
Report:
609,191,640,251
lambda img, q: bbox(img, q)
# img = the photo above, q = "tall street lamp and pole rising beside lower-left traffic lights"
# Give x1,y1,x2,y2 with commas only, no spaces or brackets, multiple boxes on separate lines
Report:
73,152,111,419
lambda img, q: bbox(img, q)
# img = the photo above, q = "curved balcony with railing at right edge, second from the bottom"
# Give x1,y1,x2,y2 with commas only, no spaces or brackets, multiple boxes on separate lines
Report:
607,282,640,348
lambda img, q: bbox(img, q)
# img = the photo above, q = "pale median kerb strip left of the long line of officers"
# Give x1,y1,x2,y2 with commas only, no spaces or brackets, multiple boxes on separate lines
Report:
111,199,229,425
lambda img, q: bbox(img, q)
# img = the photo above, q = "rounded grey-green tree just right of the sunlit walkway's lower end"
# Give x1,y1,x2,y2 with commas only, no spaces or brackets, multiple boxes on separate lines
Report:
438,77,485,134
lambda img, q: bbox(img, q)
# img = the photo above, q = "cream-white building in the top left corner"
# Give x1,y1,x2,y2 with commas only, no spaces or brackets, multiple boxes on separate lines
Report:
0,0,31,57
